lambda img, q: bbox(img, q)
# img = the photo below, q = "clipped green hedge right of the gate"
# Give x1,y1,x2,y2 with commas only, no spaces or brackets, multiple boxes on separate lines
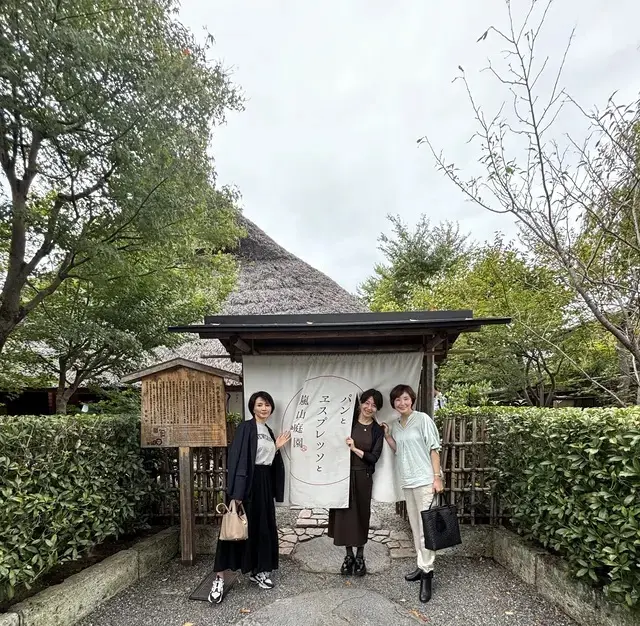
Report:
444,407,640,608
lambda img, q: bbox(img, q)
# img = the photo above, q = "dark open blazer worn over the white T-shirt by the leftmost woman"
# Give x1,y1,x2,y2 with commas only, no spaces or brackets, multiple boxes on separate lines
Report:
227,417,284,502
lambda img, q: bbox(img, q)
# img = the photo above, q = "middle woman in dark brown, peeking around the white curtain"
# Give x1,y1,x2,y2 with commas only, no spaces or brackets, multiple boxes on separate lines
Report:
328,389,384,576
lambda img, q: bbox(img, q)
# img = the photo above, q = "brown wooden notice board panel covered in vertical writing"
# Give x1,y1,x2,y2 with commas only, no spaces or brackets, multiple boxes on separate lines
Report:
141,367,227,448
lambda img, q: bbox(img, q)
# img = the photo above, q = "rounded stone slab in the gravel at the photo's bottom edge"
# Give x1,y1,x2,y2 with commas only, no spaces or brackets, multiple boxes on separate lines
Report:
232,588,424,626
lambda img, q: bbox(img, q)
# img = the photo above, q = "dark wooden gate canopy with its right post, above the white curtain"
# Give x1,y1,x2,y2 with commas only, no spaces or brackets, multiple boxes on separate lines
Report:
169,310,511,415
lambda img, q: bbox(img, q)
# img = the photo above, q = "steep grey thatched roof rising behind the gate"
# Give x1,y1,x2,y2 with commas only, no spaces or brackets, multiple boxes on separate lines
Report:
150,216,368,372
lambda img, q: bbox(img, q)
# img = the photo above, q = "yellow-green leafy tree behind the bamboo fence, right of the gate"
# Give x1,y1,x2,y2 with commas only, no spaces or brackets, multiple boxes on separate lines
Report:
413,239,596,406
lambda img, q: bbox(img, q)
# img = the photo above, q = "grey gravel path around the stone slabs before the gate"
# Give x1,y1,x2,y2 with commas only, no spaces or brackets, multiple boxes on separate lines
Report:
80,557,575,626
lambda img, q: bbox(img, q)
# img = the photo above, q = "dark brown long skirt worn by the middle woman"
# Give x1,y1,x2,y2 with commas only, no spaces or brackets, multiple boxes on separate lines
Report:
327,469,373,547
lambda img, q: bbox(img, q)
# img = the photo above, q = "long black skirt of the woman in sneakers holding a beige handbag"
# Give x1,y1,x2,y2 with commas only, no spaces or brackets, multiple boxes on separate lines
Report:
214,465,279,574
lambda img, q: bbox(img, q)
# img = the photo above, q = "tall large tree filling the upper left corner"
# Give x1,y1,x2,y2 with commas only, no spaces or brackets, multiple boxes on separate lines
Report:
0,0,241,351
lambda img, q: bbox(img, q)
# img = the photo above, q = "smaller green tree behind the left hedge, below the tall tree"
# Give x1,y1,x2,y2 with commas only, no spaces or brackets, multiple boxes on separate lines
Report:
7,190,240,413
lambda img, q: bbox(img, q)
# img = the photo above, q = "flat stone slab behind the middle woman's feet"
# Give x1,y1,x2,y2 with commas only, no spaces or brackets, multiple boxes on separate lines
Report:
291,537,391,574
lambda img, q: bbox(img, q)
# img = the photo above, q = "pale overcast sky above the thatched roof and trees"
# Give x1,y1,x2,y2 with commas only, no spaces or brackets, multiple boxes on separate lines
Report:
180,0,640,291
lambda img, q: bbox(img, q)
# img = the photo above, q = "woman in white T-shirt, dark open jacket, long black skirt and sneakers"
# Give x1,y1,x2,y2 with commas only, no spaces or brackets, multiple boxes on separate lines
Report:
209,391,291,604
